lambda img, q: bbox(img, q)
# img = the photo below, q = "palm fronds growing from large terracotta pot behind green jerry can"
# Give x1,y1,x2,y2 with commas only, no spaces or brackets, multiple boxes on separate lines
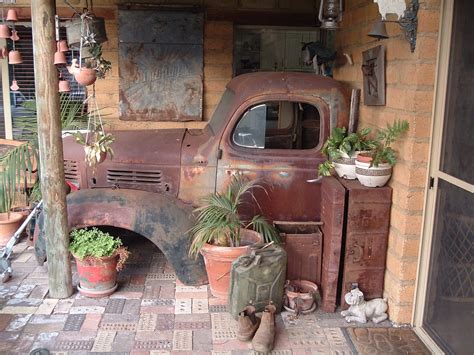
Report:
189,174,280,255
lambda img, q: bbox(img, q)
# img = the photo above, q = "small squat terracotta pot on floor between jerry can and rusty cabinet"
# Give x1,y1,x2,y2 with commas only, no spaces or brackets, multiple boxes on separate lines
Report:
285,280,318,314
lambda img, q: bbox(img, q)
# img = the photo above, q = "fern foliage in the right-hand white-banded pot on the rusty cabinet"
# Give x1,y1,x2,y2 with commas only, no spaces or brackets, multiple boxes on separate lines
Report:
368,120,410,166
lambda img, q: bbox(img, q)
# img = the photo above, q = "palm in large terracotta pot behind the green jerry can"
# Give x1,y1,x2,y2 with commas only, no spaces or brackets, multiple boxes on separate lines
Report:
189,175,279,299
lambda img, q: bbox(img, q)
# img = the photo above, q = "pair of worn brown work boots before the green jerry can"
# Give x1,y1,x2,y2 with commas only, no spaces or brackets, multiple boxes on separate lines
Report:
237,304,276,353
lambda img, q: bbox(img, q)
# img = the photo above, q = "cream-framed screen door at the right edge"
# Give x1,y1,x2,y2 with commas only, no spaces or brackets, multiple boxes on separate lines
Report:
415,0,474,354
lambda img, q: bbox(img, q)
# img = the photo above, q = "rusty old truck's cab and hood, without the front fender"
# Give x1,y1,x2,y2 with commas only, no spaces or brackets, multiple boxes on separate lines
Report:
64,72,349,221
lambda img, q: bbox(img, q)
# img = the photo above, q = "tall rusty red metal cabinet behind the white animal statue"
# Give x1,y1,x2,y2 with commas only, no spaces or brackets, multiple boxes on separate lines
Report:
339,179,392,307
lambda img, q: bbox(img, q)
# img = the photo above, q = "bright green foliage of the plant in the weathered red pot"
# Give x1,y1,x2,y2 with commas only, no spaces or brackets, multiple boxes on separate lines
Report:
69,227,130,271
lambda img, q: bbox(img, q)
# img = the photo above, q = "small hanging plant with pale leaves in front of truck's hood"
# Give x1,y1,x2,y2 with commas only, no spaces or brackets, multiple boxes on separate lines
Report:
73,129,115,167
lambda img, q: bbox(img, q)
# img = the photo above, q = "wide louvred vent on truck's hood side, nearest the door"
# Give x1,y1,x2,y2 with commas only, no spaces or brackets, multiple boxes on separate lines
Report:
107,170,161,188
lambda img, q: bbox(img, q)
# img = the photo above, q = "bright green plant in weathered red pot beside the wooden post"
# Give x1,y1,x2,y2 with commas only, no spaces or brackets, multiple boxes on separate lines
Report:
69,227,129,297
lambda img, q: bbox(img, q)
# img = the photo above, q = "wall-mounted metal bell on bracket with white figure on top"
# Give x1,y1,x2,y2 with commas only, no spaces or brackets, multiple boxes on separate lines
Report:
368,0,420,53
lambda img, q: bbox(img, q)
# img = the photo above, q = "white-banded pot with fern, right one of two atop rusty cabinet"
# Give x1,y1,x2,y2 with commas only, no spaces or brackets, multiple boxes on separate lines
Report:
355,120,409,187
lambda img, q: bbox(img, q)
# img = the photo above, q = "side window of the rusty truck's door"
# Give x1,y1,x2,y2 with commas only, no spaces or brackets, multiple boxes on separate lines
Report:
232,101,321,149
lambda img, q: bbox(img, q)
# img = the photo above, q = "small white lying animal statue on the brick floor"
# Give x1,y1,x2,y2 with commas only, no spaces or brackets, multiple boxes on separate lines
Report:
341,288,388,324
